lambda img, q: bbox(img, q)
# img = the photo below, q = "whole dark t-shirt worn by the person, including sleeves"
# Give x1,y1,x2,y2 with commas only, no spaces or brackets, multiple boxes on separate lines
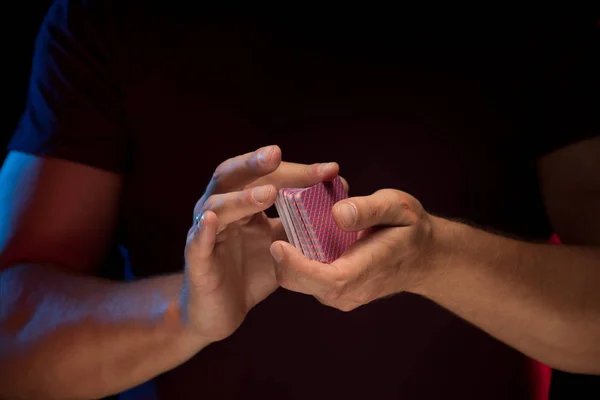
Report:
5,0,600,399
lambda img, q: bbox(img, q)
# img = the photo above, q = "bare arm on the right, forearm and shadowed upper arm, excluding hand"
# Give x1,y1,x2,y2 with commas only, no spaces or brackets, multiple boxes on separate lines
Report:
418,139,600,374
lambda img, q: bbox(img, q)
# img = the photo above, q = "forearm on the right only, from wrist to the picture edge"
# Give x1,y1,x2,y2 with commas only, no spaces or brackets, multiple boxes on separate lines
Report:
417,218,600,373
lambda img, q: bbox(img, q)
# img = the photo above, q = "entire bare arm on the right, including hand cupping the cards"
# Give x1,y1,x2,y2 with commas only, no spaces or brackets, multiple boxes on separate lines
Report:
271,138,600,374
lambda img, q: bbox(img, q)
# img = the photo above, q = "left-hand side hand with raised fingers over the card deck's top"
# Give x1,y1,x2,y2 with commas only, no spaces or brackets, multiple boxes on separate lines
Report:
182,146,339,341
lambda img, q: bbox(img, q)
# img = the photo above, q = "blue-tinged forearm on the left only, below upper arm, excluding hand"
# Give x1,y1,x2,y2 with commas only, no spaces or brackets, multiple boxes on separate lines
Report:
0,266,208,399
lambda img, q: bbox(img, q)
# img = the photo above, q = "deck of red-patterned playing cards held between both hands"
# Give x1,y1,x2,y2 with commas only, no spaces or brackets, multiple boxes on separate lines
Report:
275,177,358,263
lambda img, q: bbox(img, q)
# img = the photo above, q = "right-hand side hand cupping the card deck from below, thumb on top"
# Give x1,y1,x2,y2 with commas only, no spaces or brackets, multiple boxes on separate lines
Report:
271,189,439,311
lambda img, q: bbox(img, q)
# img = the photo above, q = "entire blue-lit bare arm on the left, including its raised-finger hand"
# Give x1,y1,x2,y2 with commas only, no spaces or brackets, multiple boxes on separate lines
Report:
0,146,339,399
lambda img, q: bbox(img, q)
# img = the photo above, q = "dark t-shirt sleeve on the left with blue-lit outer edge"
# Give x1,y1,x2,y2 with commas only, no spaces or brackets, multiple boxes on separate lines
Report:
8,0,128,173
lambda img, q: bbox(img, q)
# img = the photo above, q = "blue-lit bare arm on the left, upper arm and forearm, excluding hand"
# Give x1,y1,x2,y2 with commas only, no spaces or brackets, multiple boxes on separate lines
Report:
0,153,207,398
